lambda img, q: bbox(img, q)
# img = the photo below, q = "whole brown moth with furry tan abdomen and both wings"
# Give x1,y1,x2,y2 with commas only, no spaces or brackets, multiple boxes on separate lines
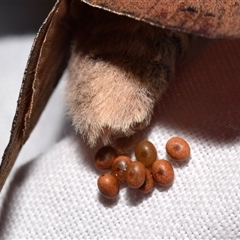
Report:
0,0,240,189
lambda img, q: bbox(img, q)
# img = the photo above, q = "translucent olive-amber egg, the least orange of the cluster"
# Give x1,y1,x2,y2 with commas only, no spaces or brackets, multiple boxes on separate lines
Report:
135,140,157,167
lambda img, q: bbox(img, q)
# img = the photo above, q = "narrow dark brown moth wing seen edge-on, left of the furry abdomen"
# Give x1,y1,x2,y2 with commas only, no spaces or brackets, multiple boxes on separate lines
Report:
0,0,73,190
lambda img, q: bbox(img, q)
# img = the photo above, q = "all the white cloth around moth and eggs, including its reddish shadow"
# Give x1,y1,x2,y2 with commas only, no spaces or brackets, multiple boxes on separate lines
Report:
0,36,240,239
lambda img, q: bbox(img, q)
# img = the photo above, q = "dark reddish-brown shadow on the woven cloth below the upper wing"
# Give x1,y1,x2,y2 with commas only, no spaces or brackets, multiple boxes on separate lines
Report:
151,40,240,143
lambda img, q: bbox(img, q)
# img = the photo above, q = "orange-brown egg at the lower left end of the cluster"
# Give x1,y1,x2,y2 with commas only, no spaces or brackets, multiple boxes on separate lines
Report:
97,173,120,199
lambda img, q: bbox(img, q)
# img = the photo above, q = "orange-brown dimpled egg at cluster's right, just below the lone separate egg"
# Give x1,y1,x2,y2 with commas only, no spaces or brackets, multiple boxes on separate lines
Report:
152,159,174,186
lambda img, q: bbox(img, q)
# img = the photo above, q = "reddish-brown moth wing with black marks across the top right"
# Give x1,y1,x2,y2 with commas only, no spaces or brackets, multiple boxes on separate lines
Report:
83,0,240,38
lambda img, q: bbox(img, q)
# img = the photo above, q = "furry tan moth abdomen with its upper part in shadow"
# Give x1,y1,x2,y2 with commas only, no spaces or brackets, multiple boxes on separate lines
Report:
67,3,191,146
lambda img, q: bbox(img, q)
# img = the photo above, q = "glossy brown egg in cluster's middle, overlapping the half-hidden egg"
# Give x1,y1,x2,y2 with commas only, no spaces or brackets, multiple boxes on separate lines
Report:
126,161,146,188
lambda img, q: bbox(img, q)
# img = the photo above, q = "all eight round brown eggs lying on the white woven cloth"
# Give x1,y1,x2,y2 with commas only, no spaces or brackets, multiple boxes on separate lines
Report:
94,137,190,199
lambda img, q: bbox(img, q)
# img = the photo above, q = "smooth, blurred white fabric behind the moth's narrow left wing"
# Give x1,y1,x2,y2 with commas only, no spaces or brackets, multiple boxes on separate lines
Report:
0,35,68,209
